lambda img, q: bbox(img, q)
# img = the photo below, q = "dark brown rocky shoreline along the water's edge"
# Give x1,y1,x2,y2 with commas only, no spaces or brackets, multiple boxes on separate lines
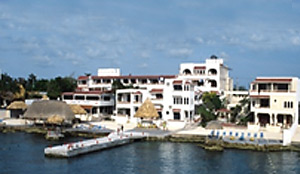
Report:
0,125,300,152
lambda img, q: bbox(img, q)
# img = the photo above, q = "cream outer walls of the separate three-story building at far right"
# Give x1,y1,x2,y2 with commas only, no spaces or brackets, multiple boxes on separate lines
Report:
250,77,300,132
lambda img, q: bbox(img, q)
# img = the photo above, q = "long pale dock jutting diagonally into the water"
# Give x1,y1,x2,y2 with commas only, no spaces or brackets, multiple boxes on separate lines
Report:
44,132,147,158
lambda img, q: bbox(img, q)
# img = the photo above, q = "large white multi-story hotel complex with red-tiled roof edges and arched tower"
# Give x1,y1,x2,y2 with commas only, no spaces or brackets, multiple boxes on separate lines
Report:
62,57,232,125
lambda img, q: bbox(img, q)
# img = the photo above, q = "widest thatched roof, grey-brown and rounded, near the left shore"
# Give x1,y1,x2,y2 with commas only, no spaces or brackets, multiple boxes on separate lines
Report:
24,100,75,121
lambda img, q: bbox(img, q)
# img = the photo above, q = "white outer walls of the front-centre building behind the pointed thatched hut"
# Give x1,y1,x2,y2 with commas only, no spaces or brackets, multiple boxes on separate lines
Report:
116,79,194,122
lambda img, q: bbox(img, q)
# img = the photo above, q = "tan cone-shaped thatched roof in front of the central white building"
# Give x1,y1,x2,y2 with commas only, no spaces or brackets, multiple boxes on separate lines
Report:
134,98,159,118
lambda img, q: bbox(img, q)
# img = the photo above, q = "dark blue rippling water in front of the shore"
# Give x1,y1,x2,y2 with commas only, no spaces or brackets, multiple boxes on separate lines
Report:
0,133,300,174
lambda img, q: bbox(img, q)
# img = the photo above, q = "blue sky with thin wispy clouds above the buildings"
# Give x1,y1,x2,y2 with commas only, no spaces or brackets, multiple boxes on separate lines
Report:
0,0,300,86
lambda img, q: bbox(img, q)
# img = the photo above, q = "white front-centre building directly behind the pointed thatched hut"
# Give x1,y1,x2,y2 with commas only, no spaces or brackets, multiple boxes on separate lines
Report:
116,79,194,123
